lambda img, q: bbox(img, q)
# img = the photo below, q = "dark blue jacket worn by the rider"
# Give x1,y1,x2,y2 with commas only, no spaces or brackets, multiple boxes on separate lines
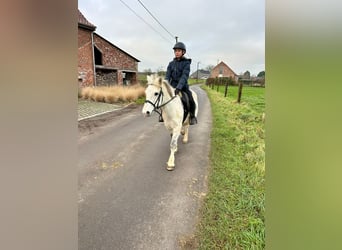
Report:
165,57,191,90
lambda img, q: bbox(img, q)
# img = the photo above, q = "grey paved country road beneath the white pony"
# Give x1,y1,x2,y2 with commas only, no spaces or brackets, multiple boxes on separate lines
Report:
78,86,211,250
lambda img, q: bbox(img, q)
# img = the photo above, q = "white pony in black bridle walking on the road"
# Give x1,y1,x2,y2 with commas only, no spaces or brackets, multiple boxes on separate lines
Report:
142,75,198,170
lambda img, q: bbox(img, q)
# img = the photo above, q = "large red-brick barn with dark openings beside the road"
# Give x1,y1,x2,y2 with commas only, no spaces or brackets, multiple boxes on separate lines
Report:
78,10,140,87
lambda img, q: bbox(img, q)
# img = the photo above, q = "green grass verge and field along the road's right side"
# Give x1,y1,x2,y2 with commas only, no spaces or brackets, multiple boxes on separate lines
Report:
195,87,265,249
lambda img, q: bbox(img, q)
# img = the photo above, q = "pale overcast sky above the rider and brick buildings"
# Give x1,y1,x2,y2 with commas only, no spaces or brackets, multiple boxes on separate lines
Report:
78,0,265,75
